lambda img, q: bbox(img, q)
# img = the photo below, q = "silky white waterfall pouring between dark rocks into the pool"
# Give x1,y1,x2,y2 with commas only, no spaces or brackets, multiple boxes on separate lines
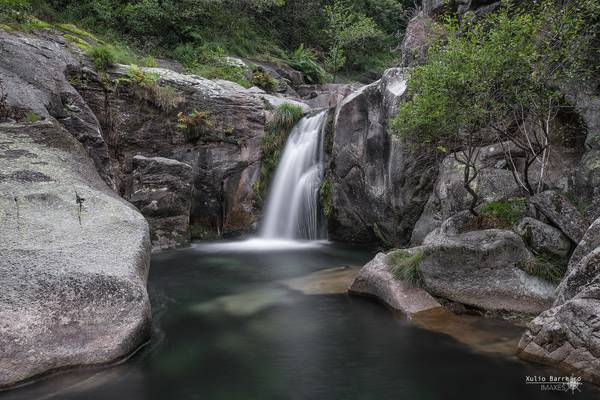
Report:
261,111,327,240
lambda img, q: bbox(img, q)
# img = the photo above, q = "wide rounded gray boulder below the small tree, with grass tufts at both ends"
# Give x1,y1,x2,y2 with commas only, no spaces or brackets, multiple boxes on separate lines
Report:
420,229,555,314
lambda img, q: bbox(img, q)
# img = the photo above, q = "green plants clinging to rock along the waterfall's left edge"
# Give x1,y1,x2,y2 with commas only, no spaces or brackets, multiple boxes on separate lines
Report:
253,103,304,202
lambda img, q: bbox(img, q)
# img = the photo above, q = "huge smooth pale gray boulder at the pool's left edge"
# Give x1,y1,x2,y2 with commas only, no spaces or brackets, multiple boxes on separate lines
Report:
0,118,150,388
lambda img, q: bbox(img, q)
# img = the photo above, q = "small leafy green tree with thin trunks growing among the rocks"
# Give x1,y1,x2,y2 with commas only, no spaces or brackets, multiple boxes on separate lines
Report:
392,0,600,209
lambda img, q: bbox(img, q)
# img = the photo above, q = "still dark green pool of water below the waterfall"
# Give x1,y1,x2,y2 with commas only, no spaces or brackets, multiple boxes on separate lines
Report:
0,244,600,400
